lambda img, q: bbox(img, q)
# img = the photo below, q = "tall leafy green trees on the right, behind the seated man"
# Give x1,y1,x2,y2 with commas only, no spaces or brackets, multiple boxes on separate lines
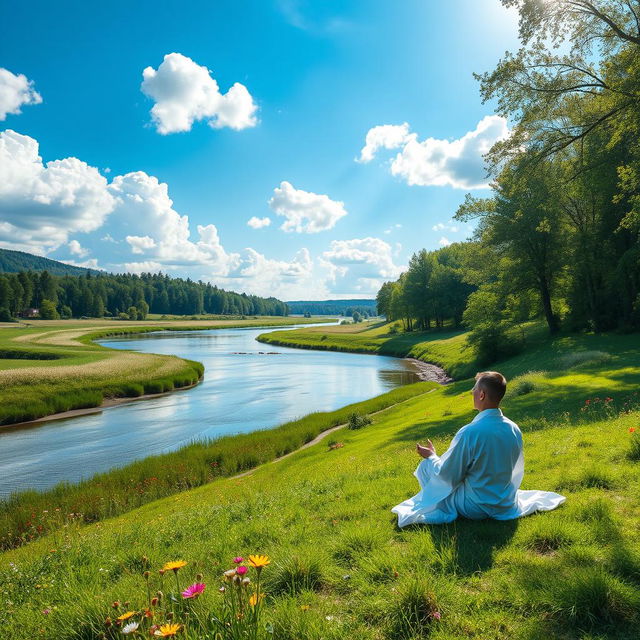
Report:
378,0,640,359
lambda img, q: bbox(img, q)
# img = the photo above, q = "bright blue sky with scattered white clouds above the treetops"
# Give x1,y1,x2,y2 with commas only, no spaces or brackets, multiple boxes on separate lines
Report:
0,0,518,300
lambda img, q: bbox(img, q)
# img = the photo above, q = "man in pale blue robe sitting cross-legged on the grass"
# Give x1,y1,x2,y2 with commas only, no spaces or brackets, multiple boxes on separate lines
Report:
391,371,566,527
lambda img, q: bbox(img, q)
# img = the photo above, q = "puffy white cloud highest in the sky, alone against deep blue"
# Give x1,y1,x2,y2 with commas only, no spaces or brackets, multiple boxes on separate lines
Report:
141,53,258,134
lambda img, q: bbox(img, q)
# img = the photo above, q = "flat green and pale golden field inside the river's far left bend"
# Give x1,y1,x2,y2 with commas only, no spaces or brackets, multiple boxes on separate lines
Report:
0,317,330,425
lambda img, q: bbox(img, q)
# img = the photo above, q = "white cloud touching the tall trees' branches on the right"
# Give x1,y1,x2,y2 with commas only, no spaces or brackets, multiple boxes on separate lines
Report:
362,115,510,189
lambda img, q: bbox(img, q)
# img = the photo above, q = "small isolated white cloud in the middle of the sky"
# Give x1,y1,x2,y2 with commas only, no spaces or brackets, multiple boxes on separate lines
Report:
269,180,347,233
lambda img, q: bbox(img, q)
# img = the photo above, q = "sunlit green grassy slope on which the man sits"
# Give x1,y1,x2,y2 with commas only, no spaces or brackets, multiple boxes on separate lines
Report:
0,324,640,640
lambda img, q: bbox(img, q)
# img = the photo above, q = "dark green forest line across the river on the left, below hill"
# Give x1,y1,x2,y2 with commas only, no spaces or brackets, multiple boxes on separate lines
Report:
0,271,288,321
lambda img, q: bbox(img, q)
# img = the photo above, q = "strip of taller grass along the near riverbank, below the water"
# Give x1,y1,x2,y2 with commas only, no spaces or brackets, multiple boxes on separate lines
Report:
0,382,440,550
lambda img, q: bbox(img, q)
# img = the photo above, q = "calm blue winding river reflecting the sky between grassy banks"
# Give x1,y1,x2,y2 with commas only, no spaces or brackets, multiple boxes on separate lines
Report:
0,327,430,498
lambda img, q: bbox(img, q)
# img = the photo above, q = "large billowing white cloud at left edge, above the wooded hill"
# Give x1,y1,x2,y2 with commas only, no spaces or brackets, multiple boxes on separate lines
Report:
0,129,115,254
